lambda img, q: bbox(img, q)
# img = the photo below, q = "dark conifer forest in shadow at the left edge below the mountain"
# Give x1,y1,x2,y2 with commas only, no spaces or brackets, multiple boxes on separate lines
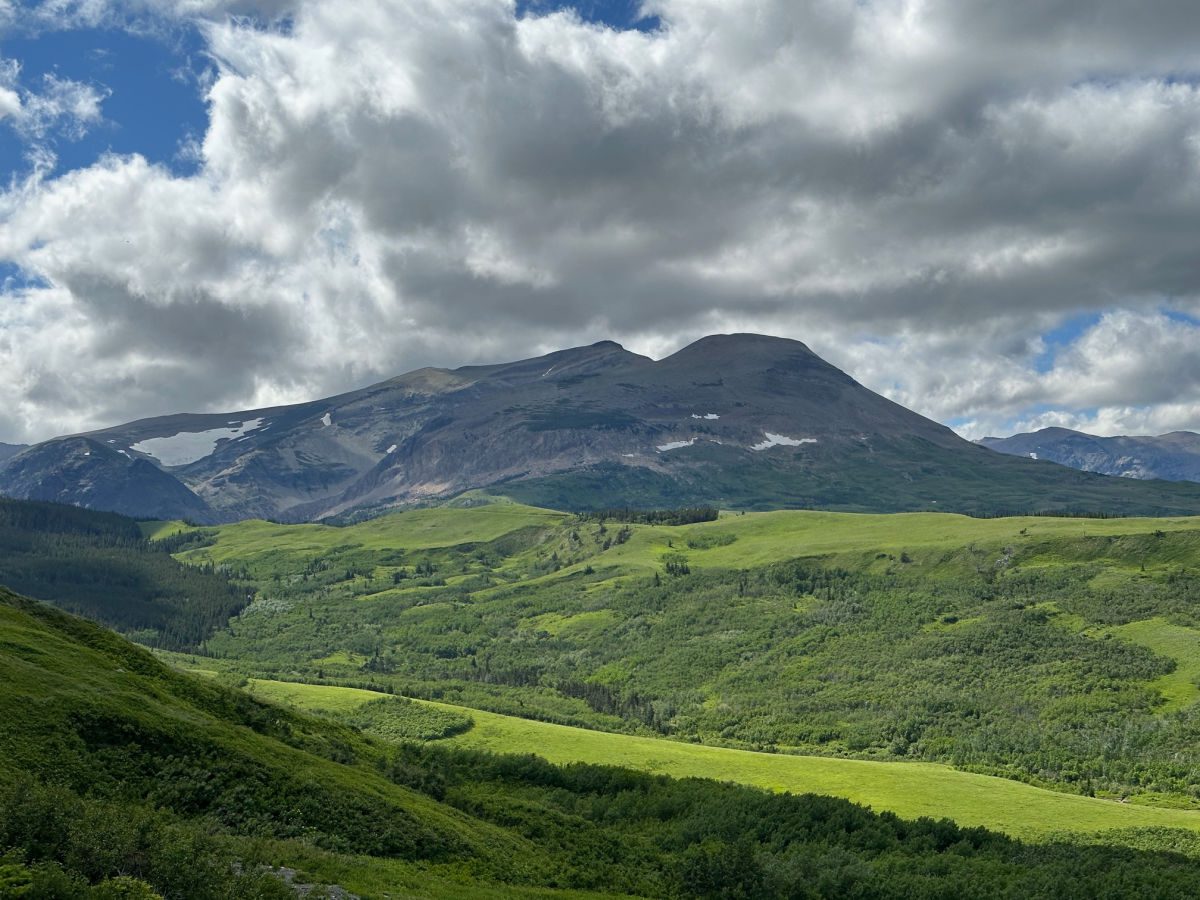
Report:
0,500,246,649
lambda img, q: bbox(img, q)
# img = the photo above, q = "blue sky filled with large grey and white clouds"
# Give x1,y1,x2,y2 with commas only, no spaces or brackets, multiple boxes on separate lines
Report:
0,0,1200,443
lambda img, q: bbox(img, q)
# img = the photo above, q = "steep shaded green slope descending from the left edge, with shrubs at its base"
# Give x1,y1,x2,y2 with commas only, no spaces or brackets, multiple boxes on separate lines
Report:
0,588,619,900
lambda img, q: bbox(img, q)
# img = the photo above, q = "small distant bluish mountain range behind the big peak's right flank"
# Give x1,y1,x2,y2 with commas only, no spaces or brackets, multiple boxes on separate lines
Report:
979,428,1200,481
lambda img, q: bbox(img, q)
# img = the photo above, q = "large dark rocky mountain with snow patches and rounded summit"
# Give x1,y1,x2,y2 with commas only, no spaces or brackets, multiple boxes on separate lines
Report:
7,335,1200,522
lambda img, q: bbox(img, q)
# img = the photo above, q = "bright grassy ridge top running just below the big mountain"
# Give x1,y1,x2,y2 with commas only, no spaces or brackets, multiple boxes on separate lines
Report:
154,502,1200,583
